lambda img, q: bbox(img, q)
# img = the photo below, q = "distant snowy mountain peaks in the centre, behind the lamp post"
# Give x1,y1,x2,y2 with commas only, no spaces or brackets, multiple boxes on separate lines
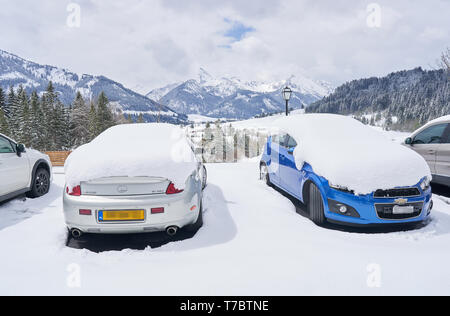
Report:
147,69,333,119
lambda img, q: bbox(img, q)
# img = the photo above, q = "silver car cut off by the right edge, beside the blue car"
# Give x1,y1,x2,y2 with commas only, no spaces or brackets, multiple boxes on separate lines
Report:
405,115,450,186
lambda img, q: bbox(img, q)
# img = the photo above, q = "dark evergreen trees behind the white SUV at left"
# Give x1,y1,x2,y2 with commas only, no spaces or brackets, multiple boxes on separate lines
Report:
0,82,131,151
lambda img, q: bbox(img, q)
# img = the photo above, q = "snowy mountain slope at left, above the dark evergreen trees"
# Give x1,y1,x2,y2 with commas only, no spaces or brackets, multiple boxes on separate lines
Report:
0,50,187,123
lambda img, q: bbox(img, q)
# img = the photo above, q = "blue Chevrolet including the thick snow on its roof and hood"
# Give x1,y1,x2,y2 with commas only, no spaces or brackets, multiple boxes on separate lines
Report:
260,114,433,225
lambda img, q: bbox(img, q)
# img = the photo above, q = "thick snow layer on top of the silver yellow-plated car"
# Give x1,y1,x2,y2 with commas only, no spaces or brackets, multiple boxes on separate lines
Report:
65,124,197,189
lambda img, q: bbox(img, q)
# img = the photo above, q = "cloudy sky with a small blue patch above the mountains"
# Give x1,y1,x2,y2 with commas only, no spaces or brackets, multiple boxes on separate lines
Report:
0,0,450,93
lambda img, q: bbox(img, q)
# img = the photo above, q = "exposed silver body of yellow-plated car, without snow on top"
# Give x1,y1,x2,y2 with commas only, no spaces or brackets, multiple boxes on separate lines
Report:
63,144,207,238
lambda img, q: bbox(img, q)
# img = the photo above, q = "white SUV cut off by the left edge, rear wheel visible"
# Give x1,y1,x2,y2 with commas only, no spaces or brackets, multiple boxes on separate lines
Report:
0,134,52,202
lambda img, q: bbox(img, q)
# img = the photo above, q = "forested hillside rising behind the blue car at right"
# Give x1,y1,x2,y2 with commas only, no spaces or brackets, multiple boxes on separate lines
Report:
306,68,450,131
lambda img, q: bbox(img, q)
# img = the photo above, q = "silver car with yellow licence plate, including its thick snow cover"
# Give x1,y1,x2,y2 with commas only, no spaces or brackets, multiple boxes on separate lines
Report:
63,124,206,238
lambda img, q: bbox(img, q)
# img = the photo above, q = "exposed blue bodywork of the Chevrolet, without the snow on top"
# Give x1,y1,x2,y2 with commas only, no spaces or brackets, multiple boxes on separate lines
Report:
260,118,433,226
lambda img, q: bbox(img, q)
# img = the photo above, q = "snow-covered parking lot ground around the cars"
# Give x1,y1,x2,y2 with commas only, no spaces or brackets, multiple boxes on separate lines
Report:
0,162,450,295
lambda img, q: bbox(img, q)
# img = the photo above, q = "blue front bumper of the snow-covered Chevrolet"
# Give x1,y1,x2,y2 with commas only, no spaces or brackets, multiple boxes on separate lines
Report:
324,189,432,226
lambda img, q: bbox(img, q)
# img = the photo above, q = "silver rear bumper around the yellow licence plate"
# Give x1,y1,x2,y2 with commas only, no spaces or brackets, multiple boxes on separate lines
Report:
63,192,201,234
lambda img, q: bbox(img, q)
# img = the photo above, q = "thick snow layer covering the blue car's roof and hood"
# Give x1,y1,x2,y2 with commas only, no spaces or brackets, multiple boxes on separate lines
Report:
273,114,431,194
